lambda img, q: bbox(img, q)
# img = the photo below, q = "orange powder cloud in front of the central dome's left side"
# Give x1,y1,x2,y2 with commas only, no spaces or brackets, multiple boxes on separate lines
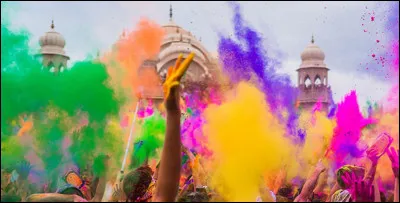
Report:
102,19,164,101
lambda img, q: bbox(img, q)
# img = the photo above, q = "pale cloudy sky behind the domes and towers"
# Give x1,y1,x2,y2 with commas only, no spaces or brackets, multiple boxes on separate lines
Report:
3,1,391,104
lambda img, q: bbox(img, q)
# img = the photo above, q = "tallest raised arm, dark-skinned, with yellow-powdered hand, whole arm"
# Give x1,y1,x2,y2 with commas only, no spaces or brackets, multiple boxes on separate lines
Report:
154,53,194,202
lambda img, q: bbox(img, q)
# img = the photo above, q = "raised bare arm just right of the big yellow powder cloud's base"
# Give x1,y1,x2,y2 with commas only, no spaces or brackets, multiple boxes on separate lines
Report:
294,160,325,202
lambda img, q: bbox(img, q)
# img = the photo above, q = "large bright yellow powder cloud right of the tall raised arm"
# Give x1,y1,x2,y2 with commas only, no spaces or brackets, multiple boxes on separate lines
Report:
203,83,291,201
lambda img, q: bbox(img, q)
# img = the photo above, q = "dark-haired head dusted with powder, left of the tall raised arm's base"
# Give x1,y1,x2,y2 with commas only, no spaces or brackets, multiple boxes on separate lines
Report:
122,166,153,201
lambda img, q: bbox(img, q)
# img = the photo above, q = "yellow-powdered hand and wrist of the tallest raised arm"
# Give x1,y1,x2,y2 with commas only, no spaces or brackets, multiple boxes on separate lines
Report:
163,53,194,110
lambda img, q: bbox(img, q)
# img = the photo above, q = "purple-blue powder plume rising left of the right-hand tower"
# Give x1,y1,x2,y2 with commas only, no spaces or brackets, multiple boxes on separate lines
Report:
218,3,297,134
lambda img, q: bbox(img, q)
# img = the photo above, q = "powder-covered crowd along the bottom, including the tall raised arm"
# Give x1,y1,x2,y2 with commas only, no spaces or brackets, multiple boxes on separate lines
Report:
1,53,399,202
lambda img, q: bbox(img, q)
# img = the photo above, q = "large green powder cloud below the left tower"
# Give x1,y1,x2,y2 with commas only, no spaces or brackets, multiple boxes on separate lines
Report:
1,4,124,179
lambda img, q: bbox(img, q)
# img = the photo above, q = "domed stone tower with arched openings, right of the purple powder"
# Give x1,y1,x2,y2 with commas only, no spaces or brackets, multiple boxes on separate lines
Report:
297,36,331,112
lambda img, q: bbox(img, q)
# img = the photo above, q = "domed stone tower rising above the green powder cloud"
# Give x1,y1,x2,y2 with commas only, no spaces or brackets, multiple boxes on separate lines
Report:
38,21,69,73
